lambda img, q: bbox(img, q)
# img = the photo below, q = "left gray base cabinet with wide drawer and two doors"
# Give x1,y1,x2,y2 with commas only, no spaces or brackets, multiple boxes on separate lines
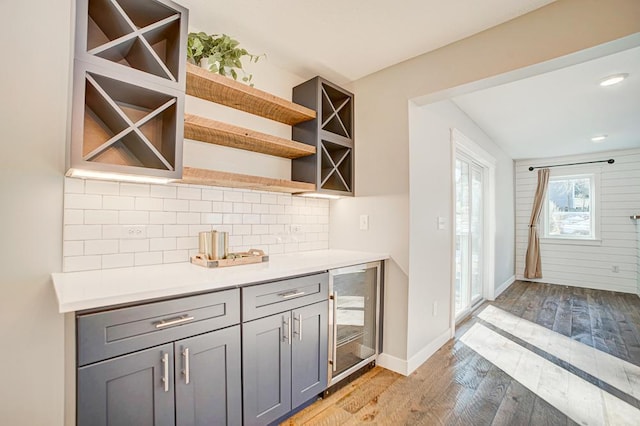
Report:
77,289,242,426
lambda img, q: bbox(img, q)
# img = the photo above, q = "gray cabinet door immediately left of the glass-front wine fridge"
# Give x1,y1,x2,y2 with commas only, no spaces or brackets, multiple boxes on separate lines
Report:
291,301,329,408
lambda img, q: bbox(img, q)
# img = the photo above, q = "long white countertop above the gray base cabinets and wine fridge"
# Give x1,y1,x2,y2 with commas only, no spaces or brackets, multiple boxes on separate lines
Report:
51,250,389,313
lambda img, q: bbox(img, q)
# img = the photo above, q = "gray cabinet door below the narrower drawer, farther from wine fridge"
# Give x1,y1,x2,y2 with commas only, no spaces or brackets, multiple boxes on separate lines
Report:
242,312,292,425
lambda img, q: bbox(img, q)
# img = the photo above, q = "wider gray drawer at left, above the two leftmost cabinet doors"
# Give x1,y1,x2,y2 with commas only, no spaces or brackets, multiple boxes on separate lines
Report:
77,289,240,366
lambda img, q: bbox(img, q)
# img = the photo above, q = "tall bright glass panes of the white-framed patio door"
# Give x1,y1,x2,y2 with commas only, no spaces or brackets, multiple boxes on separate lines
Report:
455,155,484,318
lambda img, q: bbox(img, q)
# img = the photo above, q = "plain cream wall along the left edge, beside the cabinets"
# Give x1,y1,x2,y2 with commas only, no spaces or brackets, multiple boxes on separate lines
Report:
0,0,73,426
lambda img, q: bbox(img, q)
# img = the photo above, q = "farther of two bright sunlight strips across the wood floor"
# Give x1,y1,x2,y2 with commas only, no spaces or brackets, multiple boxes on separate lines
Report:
478,305,640,402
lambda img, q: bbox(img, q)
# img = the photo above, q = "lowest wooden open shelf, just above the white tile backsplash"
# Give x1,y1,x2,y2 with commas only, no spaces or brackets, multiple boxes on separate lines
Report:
176,167,316,194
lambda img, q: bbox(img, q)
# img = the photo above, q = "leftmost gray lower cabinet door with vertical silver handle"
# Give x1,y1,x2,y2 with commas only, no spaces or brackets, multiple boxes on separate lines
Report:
77,344,175,426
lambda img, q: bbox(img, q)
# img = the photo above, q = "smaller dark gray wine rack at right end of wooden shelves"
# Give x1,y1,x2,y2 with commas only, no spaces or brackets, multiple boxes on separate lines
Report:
291,77,354,195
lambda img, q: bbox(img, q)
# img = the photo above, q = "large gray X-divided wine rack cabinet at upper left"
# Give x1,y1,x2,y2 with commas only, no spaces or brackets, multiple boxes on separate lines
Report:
68,0,188,179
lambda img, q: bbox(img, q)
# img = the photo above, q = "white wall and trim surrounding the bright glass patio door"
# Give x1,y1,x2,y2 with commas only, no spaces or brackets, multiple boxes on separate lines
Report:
409,100,515,353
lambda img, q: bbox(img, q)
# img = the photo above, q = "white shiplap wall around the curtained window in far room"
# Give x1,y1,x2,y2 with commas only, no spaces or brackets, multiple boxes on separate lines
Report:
515,149,640,293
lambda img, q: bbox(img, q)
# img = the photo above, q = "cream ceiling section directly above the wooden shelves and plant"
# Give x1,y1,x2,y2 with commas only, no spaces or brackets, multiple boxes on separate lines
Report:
178,0,553,84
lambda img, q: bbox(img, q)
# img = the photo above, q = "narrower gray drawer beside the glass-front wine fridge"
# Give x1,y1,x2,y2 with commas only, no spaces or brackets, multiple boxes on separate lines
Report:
242,272,329,321
